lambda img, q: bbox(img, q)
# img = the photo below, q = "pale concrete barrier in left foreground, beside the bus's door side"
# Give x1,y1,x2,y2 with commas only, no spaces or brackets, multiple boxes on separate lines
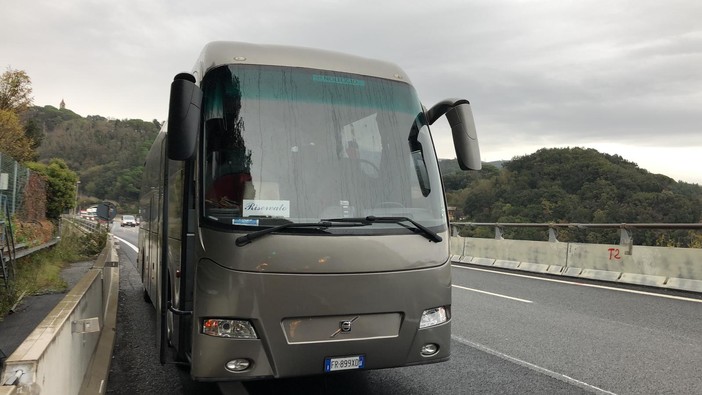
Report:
0,238,119,395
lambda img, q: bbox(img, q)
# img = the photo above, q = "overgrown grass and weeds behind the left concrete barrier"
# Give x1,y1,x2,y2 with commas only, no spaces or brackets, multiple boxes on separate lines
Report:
0,226,107,320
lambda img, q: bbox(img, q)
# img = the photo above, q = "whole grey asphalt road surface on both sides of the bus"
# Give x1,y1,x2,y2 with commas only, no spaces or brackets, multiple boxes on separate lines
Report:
107,226,702,394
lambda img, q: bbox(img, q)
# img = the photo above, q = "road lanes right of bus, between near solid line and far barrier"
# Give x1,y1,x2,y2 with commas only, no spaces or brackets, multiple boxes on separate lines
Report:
453,266,702,394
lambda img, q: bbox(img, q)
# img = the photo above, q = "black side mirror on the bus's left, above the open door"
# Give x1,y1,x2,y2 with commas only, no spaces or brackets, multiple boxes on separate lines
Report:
168,73,202,160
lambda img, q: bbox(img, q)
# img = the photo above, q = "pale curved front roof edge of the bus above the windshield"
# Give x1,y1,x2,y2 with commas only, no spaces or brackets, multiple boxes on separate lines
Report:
193,41,412,85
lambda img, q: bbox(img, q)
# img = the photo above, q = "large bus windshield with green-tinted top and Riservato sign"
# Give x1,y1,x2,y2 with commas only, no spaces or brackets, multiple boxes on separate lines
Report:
200,65,446,233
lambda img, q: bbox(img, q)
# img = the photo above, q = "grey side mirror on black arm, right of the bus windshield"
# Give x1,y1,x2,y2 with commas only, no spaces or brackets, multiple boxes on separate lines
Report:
427,99,482,170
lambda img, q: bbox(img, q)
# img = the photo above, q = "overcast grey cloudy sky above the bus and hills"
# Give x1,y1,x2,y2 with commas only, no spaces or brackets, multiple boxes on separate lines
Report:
0,0,702,184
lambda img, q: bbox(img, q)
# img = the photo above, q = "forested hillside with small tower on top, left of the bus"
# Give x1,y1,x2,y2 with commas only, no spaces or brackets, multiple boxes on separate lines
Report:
25,106,160,212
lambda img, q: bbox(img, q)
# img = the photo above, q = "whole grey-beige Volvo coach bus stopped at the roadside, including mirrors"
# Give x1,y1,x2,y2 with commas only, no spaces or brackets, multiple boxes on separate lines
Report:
137,42,481,381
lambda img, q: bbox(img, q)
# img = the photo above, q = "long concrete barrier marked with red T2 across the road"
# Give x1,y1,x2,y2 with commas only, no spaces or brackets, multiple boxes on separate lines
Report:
450,236,702,292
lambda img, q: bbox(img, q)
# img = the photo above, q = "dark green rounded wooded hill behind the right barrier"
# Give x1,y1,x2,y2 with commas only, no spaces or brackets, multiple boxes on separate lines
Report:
441,148,702,245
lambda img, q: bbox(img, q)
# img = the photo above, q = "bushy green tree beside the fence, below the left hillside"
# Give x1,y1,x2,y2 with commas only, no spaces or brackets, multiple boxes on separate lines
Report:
27,159,78,219
